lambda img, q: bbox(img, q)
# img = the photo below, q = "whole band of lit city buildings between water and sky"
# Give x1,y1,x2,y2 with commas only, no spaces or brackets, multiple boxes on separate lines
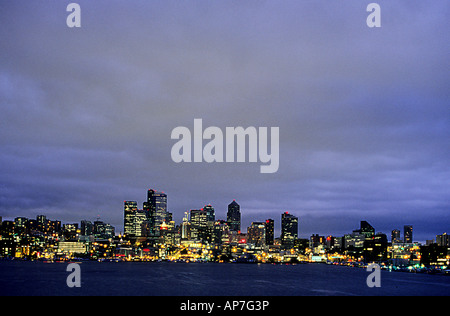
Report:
0,189,450,267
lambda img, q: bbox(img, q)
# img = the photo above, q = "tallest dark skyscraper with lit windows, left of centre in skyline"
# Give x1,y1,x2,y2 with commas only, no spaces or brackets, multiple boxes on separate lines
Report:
144,189,168,236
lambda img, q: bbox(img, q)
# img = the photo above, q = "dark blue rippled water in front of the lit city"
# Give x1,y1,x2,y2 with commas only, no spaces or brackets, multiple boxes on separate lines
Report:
0,262,450,296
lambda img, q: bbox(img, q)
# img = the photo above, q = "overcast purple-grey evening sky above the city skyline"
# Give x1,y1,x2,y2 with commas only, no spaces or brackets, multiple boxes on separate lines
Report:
0,0,450,240
